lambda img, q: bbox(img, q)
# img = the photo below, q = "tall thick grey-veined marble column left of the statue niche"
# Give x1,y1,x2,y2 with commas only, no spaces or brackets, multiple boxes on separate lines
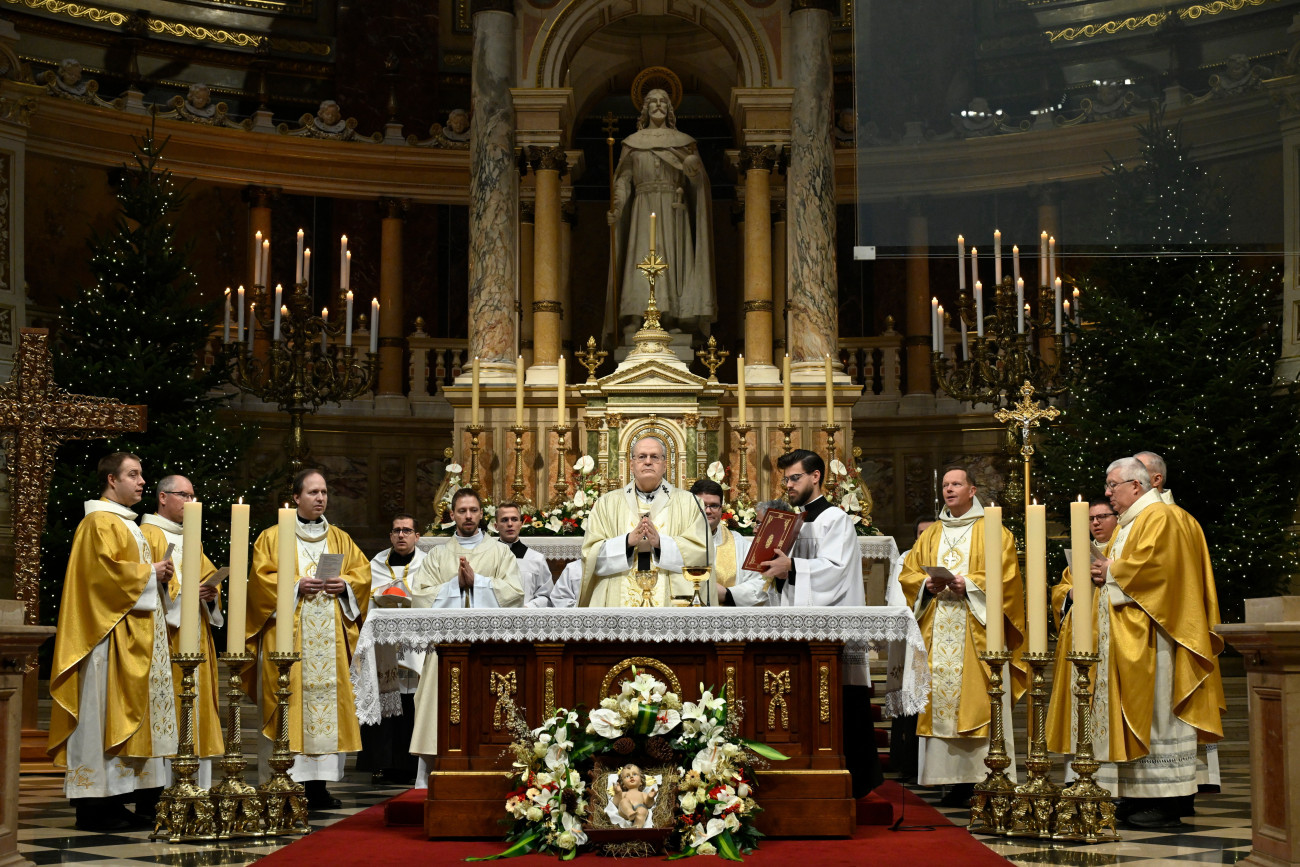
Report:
464,0,519,381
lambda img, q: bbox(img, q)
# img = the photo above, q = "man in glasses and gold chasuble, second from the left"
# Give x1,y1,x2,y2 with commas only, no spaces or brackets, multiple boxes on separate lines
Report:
140,476,226,789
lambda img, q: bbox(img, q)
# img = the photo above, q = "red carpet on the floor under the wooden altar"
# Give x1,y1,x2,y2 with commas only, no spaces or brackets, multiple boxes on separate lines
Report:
257,781,1010,867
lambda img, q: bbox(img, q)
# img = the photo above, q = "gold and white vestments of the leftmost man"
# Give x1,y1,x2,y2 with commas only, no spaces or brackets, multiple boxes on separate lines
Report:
48,499,177,798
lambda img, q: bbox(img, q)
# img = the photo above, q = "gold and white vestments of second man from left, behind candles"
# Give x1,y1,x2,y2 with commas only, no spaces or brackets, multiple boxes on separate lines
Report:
140,513,226,759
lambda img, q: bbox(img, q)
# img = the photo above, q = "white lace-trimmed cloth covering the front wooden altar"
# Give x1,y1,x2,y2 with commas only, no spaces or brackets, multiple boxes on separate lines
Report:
351,606,930,724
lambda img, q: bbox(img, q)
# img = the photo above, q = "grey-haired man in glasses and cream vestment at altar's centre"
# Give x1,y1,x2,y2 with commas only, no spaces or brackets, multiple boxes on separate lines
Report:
579,437,714,608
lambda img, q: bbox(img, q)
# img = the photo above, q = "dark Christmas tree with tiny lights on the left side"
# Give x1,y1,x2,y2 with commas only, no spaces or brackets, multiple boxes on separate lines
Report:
40,133,267,623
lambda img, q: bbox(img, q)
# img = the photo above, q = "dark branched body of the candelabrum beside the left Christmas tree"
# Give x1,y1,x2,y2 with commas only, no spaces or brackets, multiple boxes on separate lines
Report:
225,281,380,471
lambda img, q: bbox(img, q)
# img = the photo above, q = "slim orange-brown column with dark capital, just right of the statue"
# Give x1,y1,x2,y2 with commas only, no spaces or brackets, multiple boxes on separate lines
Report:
740,146,779,383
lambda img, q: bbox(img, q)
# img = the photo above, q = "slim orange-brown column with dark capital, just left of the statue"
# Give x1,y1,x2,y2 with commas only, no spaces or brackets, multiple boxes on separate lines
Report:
525,147,568,385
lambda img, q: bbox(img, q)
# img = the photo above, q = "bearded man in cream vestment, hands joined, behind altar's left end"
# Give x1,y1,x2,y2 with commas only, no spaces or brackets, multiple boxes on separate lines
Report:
411,487,524,789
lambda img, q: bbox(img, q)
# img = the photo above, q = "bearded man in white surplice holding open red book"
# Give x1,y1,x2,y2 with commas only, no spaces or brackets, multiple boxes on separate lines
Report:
759,448,884,798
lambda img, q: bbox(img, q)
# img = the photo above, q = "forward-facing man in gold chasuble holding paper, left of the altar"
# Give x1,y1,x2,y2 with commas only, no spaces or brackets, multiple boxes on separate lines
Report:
244,469,371,810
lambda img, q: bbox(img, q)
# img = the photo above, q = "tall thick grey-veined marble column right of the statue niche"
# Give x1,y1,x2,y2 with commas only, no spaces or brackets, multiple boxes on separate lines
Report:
787,0,839,380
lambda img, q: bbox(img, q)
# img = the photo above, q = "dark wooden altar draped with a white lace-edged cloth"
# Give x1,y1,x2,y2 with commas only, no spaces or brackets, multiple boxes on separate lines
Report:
351,607,930,837
